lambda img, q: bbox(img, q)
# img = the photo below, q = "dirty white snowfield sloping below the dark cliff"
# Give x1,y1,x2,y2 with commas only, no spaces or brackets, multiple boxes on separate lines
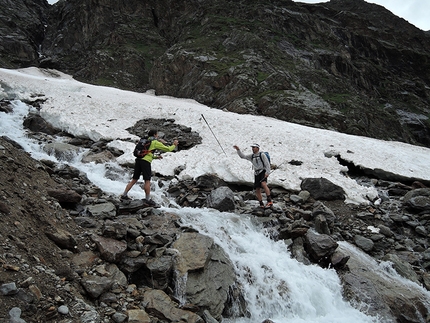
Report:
0,68,430,204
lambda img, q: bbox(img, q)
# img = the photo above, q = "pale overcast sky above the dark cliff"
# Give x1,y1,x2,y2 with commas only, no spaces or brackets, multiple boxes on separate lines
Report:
44,0,430,31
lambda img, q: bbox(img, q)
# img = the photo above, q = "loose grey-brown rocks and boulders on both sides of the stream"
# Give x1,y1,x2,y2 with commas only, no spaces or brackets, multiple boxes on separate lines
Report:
0,102,430,323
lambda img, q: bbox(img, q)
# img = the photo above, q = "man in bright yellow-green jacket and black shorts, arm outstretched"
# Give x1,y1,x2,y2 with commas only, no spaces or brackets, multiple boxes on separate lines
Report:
121,129,178,206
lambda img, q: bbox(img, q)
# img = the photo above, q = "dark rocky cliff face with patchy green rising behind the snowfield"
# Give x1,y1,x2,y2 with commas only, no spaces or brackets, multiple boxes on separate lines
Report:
0,0,430,147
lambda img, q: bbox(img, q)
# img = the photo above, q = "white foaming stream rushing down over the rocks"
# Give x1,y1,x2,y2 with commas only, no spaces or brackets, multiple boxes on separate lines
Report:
0,101,378,323
